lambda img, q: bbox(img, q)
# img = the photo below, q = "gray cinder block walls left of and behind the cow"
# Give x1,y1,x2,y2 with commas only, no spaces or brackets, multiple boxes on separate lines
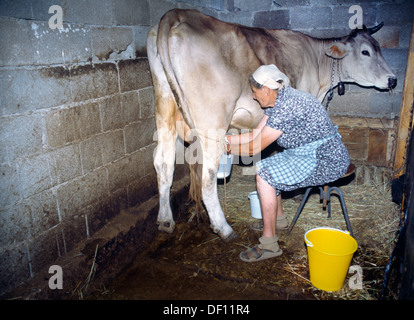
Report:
0,0,413,294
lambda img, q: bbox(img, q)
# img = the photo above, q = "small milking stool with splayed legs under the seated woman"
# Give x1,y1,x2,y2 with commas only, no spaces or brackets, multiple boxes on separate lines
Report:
287,163,355,236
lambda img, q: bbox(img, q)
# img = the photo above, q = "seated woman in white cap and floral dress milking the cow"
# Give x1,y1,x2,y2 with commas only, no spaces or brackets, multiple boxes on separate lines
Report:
225,65,349,262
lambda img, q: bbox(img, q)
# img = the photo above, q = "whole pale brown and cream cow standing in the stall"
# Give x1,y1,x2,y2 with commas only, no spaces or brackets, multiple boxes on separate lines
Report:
147,9,396,241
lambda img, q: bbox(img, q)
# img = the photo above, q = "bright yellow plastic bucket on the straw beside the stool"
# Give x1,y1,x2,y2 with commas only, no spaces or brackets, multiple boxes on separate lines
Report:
305,228,358,291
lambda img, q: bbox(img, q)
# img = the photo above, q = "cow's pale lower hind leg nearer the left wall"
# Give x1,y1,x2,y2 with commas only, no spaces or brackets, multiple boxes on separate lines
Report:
154,130,176,233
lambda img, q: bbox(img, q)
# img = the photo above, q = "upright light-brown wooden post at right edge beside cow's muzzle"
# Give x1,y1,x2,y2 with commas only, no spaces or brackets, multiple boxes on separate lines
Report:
394,23,414,178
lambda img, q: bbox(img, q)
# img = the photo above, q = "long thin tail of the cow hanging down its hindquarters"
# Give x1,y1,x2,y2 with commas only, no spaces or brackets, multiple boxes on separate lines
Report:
157,10,203,216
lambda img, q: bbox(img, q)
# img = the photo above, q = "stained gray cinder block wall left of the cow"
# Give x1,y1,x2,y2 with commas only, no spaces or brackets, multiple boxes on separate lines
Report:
0,0,157,293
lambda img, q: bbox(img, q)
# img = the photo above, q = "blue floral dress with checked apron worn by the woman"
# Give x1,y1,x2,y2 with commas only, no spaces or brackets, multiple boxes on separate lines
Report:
257,87,350,194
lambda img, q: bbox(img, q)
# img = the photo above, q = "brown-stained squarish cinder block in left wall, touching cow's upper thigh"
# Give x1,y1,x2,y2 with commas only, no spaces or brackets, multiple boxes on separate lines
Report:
118,59,152,92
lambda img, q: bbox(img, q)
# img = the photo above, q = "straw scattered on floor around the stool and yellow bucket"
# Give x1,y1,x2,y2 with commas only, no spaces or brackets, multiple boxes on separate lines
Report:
218,165,400,300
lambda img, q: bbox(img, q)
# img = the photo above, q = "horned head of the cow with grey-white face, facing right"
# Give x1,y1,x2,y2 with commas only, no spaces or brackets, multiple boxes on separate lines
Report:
326,23,397,89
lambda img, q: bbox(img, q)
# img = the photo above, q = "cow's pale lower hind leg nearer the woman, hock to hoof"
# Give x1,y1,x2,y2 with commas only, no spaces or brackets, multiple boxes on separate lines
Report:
202,149,237,241
